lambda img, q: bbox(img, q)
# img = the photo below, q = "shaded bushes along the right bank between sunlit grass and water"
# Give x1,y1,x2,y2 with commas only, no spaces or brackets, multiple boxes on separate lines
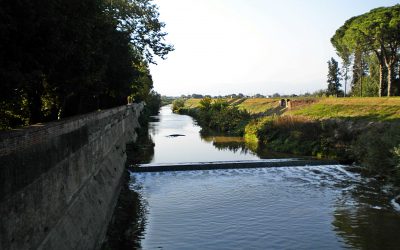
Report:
178,103,400,182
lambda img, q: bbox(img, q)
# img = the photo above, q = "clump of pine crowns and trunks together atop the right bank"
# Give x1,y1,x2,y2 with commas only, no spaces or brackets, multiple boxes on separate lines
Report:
331,4,400,96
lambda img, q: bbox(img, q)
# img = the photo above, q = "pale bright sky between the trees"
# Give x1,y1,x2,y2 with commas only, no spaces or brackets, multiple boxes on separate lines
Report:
150,0,400,96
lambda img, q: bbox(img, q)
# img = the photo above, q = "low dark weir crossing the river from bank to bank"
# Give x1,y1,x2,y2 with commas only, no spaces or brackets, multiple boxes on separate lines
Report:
130,159,338,173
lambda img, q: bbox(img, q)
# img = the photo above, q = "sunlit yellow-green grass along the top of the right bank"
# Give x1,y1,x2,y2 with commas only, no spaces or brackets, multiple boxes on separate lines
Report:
185,97,400,121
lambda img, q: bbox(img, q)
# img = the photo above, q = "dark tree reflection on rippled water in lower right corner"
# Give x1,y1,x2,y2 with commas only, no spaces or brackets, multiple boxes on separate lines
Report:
332,179,400,249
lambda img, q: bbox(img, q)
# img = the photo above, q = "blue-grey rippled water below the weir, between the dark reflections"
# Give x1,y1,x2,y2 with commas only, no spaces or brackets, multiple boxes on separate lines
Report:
131,166,400,249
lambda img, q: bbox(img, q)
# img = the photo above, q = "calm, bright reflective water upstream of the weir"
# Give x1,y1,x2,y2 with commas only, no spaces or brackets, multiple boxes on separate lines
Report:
149,106,259,163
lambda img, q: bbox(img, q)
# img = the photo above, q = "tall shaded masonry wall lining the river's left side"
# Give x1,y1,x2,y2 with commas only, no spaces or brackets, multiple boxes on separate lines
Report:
0,104,143,250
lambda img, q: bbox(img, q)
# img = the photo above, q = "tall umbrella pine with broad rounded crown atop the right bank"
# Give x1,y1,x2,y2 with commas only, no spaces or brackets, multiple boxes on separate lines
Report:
331,4,400,96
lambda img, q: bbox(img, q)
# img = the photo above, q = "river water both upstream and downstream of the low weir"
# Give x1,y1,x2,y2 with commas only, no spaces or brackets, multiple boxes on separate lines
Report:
130,107,400,249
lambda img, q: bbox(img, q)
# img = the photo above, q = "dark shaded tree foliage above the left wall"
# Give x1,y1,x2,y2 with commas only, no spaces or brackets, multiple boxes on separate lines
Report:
0,0,173,129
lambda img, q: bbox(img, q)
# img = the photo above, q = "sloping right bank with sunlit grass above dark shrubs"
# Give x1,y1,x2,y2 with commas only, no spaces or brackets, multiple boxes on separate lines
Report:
180,98,400,181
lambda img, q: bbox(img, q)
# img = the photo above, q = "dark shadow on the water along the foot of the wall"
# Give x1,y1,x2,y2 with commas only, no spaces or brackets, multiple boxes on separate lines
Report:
102,128,154,250
